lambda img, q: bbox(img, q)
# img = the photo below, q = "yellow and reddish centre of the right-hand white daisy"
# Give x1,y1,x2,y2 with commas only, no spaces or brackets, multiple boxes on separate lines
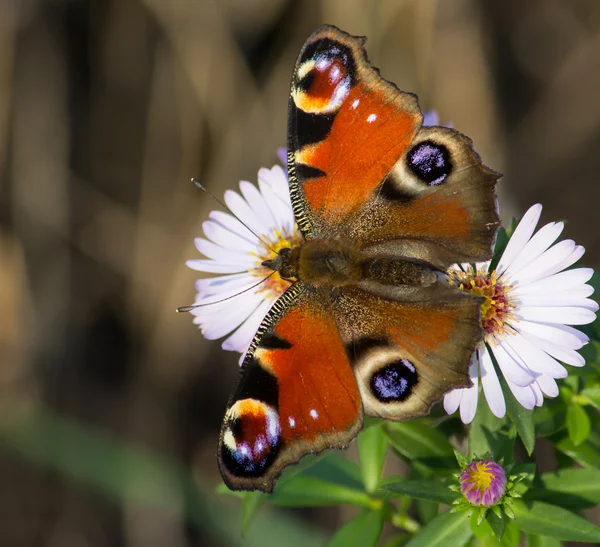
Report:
448,270,514,337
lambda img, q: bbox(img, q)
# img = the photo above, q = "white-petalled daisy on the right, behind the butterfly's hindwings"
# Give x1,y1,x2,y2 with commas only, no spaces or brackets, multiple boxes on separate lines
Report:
444,204,598,423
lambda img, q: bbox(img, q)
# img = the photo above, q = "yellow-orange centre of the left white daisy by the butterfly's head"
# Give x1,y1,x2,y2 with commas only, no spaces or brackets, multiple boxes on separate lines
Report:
249,225,304,297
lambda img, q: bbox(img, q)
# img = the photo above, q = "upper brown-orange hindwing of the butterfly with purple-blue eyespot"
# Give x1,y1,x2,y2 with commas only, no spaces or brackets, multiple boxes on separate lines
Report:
344,127,500,269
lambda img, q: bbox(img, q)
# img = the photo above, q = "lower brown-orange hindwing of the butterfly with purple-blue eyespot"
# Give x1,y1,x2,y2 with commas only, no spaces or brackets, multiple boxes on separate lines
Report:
334,283,481,421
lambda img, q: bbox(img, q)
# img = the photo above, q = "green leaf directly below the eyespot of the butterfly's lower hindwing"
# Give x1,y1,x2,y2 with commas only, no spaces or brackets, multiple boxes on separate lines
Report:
384,420,456,471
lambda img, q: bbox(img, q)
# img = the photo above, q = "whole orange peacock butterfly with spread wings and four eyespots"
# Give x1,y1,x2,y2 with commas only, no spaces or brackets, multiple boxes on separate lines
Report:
218,26,500,492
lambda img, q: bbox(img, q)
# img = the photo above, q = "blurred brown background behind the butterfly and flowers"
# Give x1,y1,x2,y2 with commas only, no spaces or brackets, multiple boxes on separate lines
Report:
0,0,600,547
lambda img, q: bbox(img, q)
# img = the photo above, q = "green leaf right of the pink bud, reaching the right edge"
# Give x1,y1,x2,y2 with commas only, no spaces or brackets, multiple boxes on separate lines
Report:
526,468,600,509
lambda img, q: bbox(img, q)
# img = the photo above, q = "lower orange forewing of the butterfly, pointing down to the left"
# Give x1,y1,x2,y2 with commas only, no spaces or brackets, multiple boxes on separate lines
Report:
219,283,362,492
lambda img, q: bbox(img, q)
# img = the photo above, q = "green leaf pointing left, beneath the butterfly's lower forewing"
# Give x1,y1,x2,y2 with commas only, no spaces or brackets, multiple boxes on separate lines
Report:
269,474,372,509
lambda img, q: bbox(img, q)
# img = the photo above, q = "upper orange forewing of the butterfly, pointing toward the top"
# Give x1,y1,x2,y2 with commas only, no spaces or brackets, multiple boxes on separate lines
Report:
288,26,422,237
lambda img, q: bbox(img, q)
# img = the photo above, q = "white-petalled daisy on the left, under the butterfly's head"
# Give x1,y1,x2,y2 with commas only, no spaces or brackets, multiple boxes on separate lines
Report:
186,161,302,364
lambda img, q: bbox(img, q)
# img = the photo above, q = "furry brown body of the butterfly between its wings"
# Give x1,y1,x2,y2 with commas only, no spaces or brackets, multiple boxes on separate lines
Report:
263,240,437,287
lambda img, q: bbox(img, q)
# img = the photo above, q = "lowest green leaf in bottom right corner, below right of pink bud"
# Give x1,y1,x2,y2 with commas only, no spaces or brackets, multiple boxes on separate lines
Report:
513,501,600,543
